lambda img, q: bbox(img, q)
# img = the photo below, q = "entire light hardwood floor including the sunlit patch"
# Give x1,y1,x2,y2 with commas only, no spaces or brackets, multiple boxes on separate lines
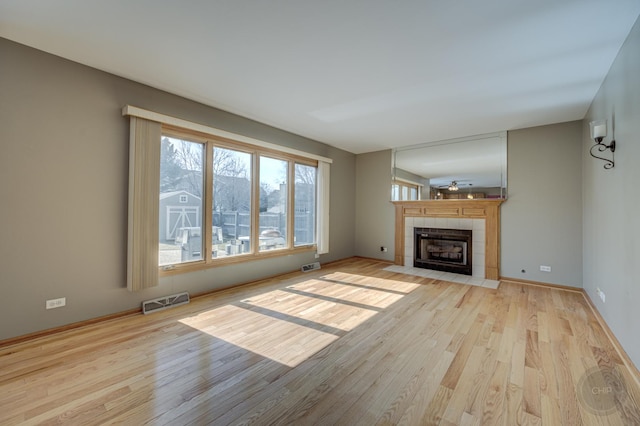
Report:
0,259,640,426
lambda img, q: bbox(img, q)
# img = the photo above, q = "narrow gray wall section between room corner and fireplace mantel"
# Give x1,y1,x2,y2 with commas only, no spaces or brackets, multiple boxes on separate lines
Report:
356,150,395,261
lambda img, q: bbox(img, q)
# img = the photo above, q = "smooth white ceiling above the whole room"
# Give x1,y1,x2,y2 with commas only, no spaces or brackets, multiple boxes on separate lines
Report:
0,0,640,153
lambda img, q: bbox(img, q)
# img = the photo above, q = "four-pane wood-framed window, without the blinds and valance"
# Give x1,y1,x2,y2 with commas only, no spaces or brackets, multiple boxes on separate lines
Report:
158,126,317,270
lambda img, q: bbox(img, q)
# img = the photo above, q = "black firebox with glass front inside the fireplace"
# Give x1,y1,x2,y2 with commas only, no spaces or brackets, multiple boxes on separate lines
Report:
413,228,473,275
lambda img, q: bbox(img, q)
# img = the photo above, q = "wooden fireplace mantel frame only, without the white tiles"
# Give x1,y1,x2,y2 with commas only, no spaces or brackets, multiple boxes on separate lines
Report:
393,199,504,280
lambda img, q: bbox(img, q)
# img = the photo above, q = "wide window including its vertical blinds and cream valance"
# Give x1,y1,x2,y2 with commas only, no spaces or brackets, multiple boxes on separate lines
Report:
122,105,332,291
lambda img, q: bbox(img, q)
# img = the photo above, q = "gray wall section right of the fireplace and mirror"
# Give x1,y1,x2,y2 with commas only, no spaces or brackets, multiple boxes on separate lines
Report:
500,121,582,287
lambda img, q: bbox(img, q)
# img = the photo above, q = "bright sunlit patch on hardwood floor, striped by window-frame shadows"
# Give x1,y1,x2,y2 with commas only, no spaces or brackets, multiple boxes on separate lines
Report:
180,272,419,367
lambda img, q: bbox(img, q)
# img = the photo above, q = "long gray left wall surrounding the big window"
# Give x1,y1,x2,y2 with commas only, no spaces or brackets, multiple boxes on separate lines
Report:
0,39,355,339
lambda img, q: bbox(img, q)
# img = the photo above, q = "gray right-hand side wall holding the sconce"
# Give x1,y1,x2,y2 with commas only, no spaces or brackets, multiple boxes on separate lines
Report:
582,20,640,366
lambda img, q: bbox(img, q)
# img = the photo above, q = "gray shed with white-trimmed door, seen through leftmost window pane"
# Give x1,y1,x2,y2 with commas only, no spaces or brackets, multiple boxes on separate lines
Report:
160,190,202,243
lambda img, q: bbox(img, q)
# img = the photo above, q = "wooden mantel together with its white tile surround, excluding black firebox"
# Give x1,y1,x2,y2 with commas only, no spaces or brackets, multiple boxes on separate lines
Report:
393,199,505,280
